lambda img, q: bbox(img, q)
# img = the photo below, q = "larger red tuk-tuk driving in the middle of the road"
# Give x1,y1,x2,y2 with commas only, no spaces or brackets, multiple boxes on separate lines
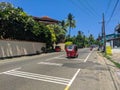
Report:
65,45,78,57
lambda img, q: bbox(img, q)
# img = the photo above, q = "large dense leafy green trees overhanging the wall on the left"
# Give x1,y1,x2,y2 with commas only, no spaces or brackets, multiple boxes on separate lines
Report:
0,2,66,48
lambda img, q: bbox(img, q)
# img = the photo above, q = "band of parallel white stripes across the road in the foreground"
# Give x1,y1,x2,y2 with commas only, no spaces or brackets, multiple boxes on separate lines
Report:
3,69,70,85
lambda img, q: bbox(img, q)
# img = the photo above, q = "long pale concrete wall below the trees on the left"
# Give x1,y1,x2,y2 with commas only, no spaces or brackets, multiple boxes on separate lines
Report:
0,40,46,58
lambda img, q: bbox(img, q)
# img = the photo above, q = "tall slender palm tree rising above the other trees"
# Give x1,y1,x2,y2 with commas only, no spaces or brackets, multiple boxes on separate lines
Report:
67,13,76,37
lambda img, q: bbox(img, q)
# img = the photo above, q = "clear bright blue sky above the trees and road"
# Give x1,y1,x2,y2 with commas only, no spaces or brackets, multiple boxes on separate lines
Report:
0,0,120,38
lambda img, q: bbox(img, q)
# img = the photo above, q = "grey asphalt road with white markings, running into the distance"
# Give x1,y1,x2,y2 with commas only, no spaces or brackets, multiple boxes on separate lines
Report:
0,48,117,90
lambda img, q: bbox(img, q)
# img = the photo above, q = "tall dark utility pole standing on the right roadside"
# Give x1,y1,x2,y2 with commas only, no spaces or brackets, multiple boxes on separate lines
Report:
102,13,106,52
